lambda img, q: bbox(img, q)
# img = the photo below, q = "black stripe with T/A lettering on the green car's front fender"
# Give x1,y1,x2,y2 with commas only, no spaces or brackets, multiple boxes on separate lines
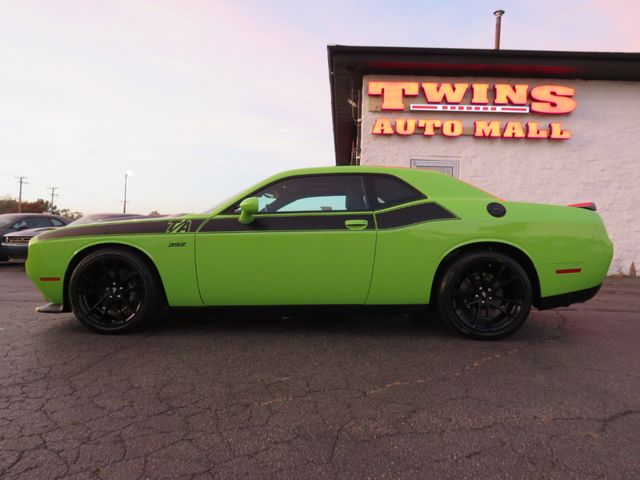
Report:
38,218,204,240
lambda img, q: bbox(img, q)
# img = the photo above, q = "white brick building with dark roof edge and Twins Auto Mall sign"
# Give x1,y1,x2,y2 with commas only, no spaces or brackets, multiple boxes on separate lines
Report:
329,46,640,275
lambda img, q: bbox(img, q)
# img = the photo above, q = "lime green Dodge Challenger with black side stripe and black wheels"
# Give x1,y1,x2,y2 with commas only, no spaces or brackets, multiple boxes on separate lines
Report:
27,167,613,339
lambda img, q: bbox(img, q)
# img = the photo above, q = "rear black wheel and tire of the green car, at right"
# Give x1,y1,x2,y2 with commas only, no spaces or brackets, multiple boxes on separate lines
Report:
437,251,533,340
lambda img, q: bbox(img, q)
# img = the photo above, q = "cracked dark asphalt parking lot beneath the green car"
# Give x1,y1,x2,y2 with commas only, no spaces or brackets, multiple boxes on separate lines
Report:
0,264,640,479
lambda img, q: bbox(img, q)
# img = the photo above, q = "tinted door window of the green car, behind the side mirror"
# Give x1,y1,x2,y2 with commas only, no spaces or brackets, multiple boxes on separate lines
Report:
234,175,369,213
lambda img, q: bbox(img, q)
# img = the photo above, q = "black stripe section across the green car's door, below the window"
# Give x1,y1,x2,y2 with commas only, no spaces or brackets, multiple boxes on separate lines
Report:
200,215,375,233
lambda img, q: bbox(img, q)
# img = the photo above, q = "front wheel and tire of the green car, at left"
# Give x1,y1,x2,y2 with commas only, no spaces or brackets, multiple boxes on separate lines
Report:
69,248,162,334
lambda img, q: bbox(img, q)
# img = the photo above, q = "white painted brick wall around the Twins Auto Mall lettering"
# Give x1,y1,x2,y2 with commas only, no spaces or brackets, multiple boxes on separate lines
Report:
360,75,640,275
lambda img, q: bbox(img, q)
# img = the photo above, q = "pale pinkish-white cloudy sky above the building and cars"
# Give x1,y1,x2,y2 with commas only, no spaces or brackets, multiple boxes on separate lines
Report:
0,0,640,213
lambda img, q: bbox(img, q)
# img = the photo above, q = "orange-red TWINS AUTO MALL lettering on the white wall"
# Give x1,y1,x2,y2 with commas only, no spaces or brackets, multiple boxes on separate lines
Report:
368,81,576,140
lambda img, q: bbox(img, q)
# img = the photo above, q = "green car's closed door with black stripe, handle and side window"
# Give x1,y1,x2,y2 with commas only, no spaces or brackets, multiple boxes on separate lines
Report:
196,174,376,305
